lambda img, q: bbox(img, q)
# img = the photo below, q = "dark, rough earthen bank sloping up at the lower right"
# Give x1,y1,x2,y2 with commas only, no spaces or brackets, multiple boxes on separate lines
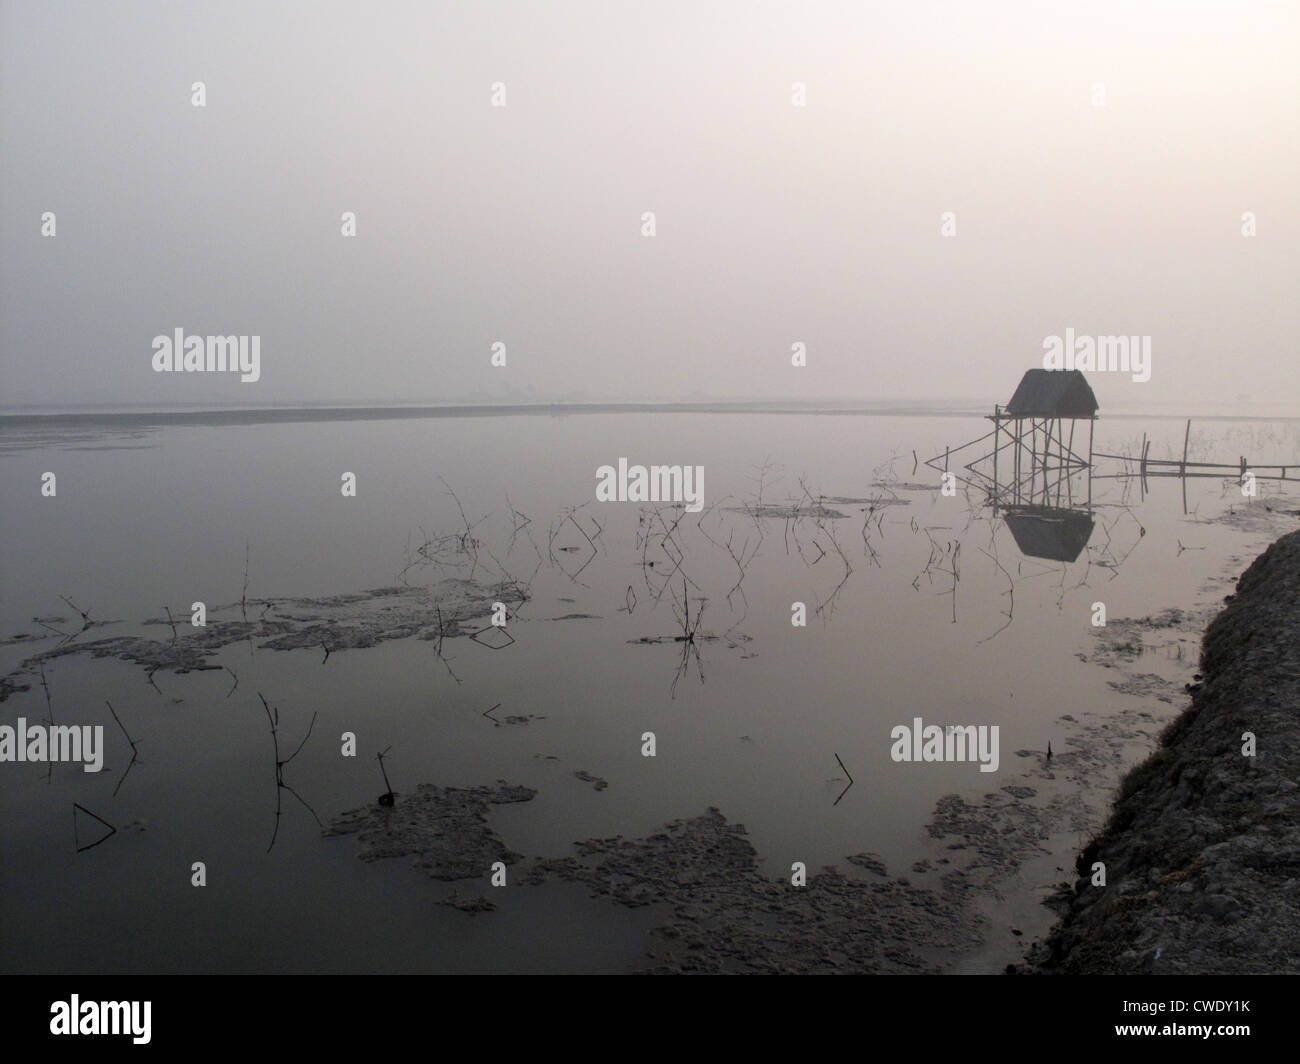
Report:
1027,532,1300,974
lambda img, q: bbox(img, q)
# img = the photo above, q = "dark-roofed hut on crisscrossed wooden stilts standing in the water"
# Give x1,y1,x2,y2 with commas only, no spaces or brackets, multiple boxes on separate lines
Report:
989,369,1097,509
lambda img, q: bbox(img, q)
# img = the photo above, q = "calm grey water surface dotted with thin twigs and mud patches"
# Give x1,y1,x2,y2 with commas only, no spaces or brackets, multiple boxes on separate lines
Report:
0,411,1300,972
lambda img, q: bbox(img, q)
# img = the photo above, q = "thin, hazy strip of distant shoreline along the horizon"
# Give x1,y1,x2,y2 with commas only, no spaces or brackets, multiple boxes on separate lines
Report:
0,401,1300,429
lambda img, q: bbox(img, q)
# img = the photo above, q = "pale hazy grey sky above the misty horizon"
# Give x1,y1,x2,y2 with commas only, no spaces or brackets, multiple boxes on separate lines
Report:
0,0,1300,414
